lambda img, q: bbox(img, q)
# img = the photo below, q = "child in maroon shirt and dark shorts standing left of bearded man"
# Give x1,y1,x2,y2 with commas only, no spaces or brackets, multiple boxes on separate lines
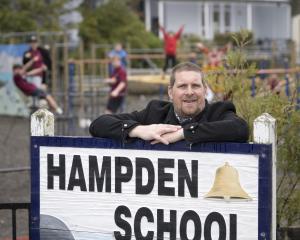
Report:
105,56,127,114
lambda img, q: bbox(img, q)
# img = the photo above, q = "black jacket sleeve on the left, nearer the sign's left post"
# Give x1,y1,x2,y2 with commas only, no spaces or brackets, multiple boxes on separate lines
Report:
89,104,147,142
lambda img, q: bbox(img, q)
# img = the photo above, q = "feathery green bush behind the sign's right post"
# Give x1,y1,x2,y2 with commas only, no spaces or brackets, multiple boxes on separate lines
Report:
207,31,300,227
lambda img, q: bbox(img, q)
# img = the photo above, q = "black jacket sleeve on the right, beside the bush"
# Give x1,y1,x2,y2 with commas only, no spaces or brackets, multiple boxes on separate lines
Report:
184,102,249,143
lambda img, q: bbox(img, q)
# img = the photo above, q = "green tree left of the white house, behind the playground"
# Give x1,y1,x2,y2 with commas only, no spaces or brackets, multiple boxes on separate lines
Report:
80,0,161,48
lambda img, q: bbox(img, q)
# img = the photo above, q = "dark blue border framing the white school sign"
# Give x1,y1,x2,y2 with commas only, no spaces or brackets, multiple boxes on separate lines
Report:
30,137,272,240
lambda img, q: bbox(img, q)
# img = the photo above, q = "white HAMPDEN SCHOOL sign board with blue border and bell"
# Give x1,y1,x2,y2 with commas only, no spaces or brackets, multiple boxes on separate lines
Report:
31,137,272,240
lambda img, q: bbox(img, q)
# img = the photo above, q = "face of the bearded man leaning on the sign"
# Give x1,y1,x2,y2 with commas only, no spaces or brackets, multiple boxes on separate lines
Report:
168,71,206,117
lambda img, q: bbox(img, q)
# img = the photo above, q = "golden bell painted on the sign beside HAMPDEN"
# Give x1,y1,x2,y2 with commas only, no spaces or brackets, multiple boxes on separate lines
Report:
204,162,252,200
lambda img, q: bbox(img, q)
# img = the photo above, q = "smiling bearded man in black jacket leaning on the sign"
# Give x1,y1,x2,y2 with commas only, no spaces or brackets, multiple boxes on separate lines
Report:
90,63,249,144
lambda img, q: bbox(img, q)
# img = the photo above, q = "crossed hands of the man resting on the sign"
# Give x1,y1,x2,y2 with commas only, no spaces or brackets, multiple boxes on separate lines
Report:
129,124,181,145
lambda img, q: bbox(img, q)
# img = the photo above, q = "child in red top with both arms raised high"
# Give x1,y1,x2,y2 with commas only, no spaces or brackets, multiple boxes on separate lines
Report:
159,25,184,73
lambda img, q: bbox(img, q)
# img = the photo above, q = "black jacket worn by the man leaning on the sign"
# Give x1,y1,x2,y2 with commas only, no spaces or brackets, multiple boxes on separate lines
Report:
90,100,249,143
